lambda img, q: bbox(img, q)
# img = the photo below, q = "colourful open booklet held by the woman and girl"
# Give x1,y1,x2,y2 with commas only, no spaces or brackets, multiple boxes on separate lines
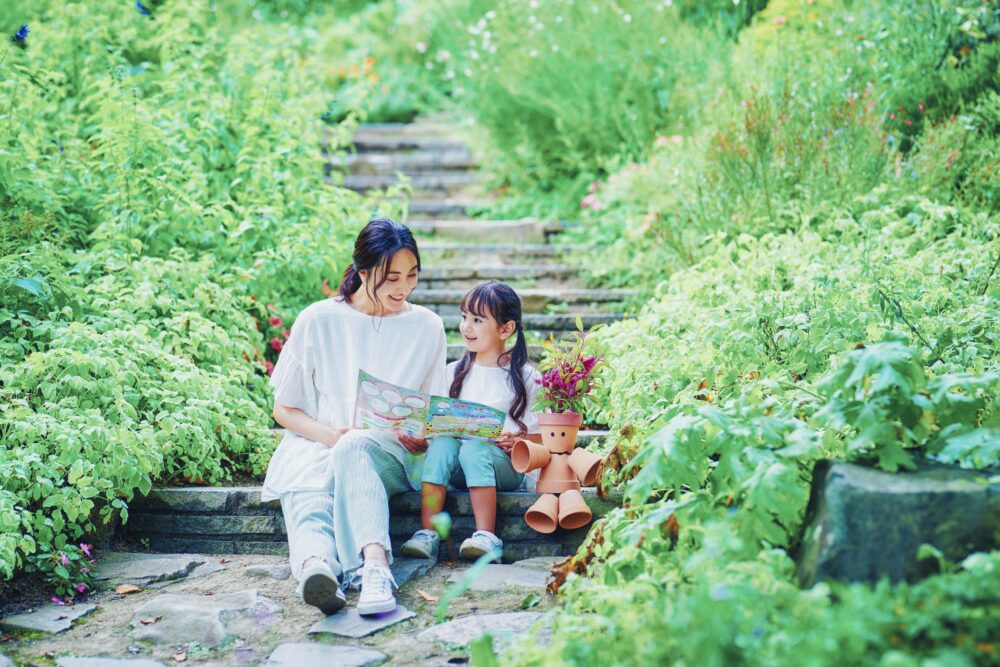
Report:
354,370,507,440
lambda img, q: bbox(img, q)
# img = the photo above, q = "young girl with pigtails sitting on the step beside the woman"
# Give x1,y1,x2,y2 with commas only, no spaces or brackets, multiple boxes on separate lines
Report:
400,281,541,559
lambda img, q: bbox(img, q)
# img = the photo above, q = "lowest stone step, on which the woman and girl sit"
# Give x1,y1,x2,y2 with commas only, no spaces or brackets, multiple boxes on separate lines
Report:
121,487,620,561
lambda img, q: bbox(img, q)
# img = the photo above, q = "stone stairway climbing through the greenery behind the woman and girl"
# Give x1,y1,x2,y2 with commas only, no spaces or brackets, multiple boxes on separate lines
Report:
123,120,631,561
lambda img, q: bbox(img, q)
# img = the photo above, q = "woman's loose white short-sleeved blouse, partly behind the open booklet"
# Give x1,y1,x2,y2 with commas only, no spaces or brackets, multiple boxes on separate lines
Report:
261,297,447,501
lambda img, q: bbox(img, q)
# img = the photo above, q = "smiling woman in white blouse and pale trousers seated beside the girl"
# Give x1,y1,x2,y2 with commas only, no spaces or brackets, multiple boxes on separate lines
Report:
261,219,446,614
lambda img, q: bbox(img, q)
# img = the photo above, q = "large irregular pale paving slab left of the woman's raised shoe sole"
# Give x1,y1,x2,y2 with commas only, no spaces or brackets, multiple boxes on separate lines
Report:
130,590,281,648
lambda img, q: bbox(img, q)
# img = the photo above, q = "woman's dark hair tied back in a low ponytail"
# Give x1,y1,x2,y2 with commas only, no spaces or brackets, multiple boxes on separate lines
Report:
340,218,420,307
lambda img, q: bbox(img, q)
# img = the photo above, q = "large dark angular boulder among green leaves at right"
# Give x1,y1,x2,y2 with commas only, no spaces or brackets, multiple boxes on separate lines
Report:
797,462,1000,586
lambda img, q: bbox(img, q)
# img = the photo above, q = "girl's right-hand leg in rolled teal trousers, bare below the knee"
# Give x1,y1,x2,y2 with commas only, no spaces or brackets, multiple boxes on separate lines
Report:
458,440,524,533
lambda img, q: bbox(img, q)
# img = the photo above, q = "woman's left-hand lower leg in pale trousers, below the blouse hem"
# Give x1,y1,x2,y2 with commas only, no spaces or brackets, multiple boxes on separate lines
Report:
281,491,343,579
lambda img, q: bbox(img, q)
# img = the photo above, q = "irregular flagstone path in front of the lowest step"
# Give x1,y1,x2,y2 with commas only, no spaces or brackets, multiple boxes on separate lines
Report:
0,553,557,667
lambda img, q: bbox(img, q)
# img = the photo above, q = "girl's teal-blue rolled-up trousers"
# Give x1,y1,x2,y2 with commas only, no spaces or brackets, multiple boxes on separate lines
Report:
422,436,524,491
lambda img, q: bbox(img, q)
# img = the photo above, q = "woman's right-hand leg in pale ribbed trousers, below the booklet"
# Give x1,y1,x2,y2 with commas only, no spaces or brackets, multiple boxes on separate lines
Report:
333,431,410,572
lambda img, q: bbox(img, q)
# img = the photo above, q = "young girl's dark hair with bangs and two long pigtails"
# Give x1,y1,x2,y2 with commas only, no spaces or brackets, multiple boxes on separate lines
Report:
448,280,528,431
